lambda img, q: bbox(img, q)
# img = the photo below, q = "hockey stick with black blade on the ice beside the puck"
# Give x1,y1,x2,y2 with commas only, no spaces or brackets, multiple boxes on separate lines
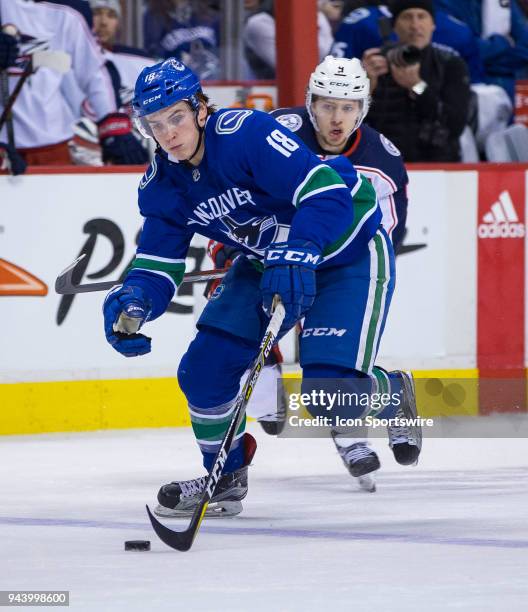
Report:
146,295,285,552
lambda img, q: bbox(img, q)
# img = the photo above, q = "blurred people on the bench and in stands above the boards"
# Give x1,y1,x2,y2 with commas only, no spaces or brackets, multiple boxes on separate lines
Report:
0,0,528,173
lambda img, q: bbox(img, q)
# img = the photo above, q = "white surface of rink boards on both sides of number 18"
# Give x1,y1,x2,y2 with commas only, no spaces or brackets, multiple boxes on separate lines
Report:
0,171,477,382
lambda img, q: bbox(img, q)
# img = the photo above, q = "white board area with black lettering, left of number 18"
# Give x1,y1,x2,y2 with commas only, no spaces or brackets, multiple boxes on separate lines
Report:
0,174,203,382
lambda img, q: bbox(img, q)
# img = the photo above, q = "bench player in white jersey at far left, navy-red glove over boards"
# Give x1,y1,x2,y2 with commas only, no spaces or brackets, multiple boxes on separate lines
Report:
0,0,148,171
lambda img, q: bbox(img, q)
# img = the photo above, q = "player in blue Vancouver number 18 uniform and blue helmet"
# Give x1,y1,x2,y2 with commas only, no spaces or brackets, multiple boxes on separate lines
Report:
103,59,419,516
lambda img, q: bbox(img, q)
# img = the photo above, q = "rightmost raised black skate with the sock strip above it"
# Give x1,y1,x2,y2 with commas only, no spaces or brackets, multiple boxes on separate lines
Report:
387,371,422,465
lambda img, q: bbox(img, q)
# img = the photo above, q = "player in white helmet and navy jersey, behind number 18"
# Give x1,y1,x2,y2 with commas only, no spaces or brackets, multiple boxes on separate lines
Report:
209,56,419,490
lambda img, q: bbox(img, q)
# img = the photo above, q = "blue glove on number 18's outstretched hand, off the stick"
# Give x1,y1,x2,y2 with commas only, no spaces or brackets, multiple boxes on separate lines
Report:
103,286,152,357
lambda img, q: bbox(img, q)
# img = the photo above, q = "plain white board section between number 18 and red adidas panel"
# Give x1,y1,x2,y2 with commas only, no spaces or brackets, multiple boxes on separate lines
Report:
378,170,478,369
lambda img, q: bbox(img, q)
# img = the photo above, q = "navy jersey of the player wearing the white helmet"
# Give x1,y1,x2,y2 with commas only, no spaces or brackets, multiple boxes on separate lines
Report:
271,106,409,248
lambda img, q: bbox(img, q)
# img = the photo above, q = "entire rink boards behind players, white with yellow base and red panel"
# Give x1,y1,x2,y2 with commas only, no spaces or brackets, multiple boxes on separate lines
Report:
0,165,528,433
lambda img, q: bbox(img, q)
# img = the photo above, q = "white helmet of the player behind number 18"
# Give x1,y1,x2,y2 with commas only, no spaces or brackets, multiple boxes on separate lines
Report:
306,55,370,131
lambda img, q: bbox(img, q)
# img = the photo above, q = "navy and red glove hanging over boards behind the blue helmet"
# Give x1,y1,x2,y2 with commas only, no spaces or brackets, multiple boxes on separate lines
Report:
97,113,149,165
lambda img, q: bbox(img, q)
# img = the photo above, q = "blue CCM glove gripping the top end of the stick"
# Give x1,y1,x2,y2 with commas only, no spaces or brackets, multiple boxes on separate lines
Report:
260,240,321,329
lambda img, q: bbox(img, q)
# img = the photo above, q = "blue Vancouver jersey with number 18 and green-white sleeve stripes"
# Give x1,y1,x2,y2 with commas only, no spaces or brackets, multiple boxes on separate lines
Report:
125,109,382,318
